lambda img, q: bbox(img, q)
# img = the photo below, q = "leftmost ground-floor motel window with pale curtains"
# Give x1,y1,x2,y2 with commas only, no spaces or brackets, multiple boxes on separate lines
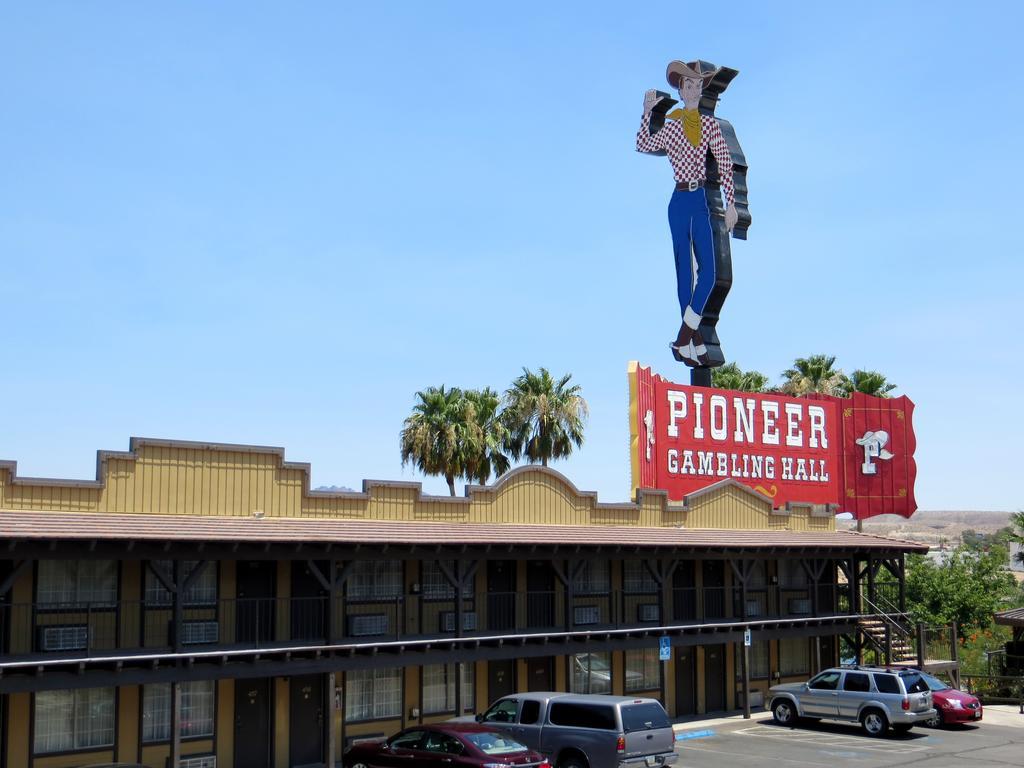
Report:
33,688,114,755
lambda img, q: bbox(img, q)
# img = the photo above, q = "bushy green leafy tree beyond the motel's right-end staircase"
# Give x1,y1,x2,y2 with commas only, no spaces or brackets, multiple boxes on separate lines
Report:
906,547,1018,635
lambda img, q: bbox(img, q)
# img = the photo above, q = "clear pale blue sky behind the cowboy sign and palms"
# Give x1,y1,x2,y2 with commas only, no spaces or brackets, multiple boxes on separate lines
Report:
0,2,1024,510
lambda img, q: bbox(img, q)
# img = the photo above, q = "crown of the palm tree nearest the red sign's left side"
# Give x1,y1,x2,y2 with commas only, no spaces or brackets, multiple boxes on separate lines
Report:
503,368,589,467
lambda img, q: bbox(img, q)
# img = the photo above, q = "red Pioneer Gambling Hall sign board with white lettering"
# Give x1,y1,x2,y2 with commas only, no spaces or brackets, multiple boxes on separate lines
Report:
630,366,916,517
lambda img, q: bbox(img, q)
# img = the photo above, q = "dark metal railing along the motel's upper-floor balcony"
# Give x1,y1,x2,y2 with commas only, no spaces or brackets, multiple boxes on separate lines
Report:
0,584,853,656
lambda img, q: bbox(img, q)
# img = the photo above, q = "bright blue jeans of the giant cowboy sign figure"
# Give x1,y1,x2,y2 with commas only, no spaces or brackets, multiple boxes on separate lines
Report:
669,189,717,314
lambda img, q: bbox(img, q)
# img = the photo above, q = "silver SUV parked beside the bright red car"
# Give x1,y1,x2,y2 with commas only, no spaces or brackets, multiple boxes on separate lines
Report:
768,667,935,736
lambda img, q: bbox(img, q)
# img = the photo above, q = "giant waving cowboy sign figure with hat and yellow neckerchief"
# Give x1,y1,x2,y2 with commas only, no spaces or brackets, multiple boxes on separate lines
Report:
637,61,750,368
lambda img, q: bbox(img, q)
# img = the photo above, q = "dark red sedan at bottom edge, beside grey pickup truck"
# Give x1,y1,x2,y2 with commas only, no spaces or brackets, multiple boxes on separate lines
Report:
344,723,551,768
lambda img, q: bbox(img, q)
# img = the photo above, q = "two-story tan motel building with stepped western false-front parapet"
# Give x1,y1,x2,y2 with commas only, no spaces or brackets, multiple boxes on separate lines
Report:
0,438,924,768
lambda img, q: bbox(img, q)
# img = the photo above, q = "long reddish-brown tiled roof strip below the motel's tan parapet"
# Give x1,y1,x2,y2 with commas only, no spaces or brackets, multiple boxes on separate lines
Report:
0,511,928,552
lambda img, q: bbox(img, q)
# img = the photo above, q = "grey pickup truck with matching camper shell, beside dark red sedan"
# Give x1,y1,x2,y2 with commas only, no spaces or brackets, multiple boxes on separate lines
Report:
476,692,677,768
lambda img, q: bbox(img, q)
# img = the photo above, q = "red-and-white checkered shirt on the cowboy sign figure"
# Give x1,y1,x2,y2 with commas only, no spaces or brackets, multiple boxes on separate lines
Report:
637,113,736,206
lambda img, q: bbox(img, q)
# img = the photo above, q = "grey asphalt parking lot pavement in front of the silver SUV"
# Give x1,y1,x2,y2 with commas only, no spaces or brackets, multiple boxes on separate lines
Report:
676,713,1024,768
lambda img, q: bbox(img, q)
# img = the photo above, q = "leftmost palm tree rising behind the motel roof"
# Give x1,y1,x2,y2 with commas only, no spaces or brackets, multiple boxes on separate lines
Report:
400,384,476,496
